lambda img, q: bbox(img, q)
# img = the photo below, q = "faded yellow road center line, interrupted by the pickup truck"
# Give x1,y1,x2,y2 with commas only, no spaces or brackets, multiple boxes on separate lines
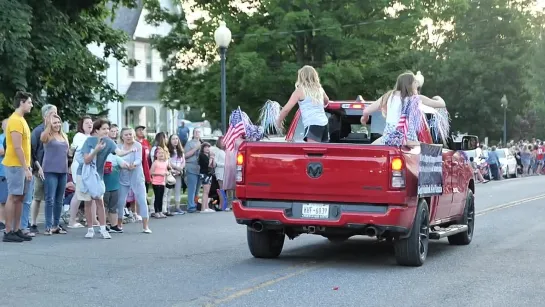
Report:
193,194,545,307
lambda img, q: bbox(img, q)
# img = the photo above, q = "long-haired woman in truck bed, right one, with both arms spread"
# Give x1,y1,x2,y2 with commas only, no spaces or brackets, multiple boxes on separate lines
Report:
361,72,445,145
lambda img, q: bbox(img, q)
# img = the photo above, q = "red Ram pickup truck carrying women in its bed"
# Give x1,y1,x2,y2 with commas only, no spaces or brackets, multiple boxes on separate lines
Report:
233,101,478,266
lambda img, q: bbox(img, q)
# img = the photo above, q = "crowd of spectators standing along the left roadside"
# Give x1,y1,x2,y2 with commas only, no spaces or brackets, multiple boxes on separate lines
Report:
0,92,230,242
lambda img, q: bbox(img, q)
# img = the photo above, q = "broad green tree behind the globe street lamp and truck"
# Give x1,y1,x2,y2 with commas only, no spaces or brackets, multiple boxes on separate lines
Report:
151,0,434,126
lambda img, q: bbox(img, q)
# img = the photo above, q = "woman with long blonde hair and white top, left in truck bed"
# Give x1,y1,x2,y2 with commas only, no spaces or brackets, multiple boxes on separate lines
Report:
277,65,329,143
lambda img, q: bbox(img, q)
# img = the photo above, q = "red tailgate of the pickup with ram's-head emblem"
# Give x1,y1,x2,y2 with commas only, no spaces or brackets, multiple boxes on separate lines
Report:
241,143,397,203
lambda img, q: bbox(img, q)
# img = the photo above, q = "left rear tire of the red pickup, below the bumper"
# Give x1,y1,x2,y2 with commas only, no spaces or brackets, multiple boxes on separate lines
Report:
246,227,286,258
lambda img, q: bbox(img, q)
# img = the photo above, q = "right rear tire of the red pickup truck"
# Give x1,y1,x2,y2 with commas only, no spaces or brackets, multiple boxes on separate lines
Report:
394,199,430,267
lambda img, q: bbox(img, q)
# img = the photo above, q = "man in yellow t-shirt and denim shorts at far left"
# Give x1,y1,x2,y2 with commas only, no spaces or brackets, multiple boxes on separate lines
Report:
2,92,32,242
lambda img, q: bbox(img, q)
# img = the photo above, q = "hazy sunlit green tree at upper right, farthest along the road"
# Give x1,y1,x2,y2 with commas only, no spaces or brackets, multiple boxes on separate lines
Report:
419,0,540,139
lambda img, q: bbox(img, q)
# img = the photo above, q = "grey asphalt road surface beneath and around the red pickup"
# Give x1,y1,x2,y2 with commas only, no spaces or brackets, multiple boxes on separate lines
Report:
0,177,545,307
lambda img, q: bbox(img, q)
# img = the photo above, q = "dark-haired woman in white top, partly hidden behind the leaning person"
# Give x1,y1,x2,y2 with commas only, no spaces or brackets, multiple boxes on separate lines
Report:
68,115,96,228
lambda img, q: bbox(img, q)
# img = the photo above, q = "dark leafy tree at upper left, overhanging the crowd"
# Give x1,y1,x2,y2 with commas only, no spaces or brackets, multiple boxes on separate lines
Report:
0,0,135,126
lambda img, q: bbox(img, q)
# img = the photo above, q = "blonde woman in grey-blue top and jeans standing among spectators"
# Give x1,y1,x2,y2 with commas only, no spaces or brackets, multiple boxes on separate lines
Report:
40,115,69,235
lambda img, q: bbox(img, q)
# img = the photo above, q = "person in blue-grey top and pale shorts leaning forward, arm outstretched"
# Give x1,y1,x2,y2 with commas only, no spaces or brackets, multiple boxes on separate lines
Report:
76,119,133,239
